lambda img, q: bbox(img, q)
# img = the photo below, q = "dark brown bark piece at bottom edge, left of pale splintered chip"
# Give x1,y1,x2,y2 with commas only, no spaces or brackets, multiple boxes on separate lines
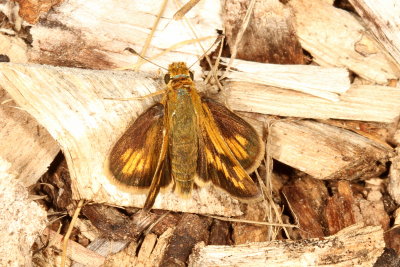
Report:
160,214,209,266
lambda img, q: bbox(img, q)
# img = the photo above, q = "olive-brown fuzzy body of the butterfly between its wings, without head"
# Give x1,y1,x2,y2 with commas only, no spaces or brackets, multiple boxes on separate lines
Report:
168,88,198,196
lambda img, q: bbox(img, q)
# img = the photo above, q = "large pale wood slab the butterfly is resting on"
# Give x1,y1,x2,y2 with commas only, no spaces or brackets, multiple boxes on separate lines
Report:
0,63,241,216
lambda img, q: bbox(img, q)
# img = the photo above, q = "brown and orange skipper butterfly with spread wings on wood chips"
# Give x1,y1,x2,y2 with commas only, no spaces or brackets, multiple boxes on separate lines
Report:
107,62,264,210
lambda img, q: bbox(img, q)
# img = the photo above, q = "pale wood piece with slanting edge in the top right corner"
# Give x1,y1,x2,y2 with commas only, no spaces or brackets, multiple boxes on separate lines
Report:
349,0,400,66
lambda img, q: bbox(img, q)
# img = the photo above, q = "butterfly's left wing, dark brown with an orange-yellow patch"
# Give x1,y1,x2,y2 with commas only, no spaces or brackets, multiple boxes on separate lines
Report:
109,103,171,192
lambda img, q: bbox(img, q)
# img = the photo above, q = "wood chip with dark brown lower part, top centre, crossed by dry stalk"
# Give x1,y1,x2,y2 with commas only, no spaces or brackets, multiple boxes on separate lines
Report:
223,0,303,64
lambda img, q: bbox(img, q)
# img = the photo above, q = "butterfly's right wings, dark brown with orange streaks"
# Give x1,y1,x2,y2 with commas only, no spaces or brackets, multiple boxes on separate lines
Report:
197,98,263,200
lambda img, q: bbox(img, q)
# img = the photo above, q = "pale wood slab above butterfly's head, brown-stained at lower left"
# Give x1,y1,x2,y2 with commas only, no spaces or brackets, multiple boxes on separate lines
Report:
30,0,222,75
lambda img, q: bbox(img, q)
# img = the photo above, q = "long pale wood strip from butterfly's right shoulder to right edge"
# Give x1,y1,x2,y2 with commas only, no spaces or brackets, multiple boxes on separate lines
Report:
225,82,400,123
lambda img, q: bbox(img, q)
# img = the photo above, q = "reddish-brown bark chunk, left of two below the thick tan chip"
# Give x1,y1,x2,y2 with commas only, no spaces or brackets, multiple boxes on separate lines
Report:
282,177,328,238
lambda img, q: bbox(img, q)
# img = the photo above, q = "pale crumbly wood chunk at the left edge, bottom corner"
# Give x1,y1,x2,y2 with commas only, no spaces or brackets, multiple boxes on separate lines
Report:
0,158,47,266
